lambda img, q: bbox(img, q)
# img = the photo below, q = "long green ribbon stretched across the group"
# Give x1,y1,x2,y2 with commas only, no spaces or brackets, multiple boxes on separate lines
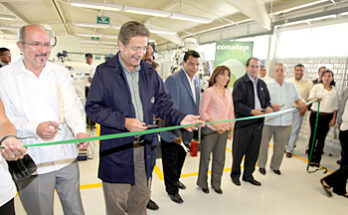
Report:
0,99,317,149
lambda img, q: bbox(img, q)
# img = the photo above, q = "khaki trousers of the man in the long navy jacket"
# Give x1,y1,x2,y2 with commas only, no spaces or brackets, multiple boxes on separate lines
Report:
103,147,151,215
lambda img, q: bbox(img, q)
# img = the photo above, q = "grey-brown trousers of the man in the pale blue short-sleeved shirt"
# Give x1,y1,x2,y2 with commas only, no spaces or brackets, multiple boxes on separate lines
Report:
257,125,289,170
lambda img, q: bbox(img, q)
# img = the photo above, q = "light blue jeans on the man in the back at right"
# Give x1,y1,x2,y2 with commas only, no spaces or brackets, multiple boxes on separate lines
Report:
286,109,303,153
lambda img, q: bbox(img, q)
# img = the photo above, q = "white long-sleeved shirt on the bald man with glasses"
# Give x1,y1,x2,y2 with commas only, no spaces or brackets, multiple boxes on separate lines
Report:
0,58,86,174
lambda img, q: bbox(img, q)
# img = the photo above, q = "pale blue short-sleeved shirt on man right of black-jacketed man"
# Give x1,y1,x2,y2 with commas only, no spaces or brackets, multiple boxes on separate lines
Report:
265,80,301,126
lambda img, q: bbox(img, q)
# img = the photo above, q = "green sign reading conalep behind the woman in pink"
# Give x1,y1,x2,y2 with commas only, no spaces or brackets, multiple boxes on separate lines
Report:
214,41,254,87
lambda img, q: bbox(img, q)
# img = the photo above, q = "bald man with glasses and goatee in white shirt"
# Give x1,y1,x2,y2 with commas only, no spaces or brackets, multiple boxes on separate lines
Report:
0,25,88,215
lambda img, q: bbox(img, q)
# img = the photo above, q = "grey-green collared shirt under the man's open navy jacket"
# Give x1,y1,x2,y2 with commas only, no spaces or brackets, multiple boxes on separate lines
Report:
118,55,144,122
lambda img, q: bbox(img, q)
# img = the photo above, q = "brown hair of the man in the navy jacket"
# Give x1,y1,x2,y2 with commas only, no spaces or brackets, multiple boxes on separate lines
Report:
118,21,150,46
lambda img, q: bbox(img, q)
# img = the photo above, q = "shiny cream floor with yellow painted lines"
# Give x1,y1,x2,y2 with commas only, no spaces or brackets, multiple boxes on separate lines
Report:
15,137,348,215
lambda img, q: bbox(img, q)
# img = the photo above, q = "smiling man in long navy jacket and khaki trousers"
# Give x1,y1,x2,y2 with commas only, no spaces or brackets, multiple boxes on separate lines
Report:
86,21,204,215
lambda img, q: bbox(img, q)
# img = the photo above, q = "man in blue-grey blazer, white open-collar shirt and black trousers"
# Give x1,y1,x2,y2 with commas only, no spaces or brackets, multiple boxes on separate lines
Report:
161,50,200,203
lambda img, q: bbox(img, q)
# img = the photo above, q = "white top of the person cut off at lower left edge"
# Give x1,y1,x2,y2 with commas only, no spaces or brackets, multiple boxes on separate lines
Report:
0,158,17,207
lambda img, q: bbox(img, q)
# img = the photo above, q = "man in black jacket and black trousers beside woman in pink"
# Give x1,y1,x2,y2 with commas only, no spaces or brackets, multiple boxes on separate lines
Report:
231,57,272,186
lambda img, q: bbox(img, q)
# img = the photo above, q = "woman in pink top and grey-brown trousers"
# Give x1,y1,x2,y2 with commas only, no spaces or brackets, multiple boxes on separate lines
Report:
197,66,234,194
